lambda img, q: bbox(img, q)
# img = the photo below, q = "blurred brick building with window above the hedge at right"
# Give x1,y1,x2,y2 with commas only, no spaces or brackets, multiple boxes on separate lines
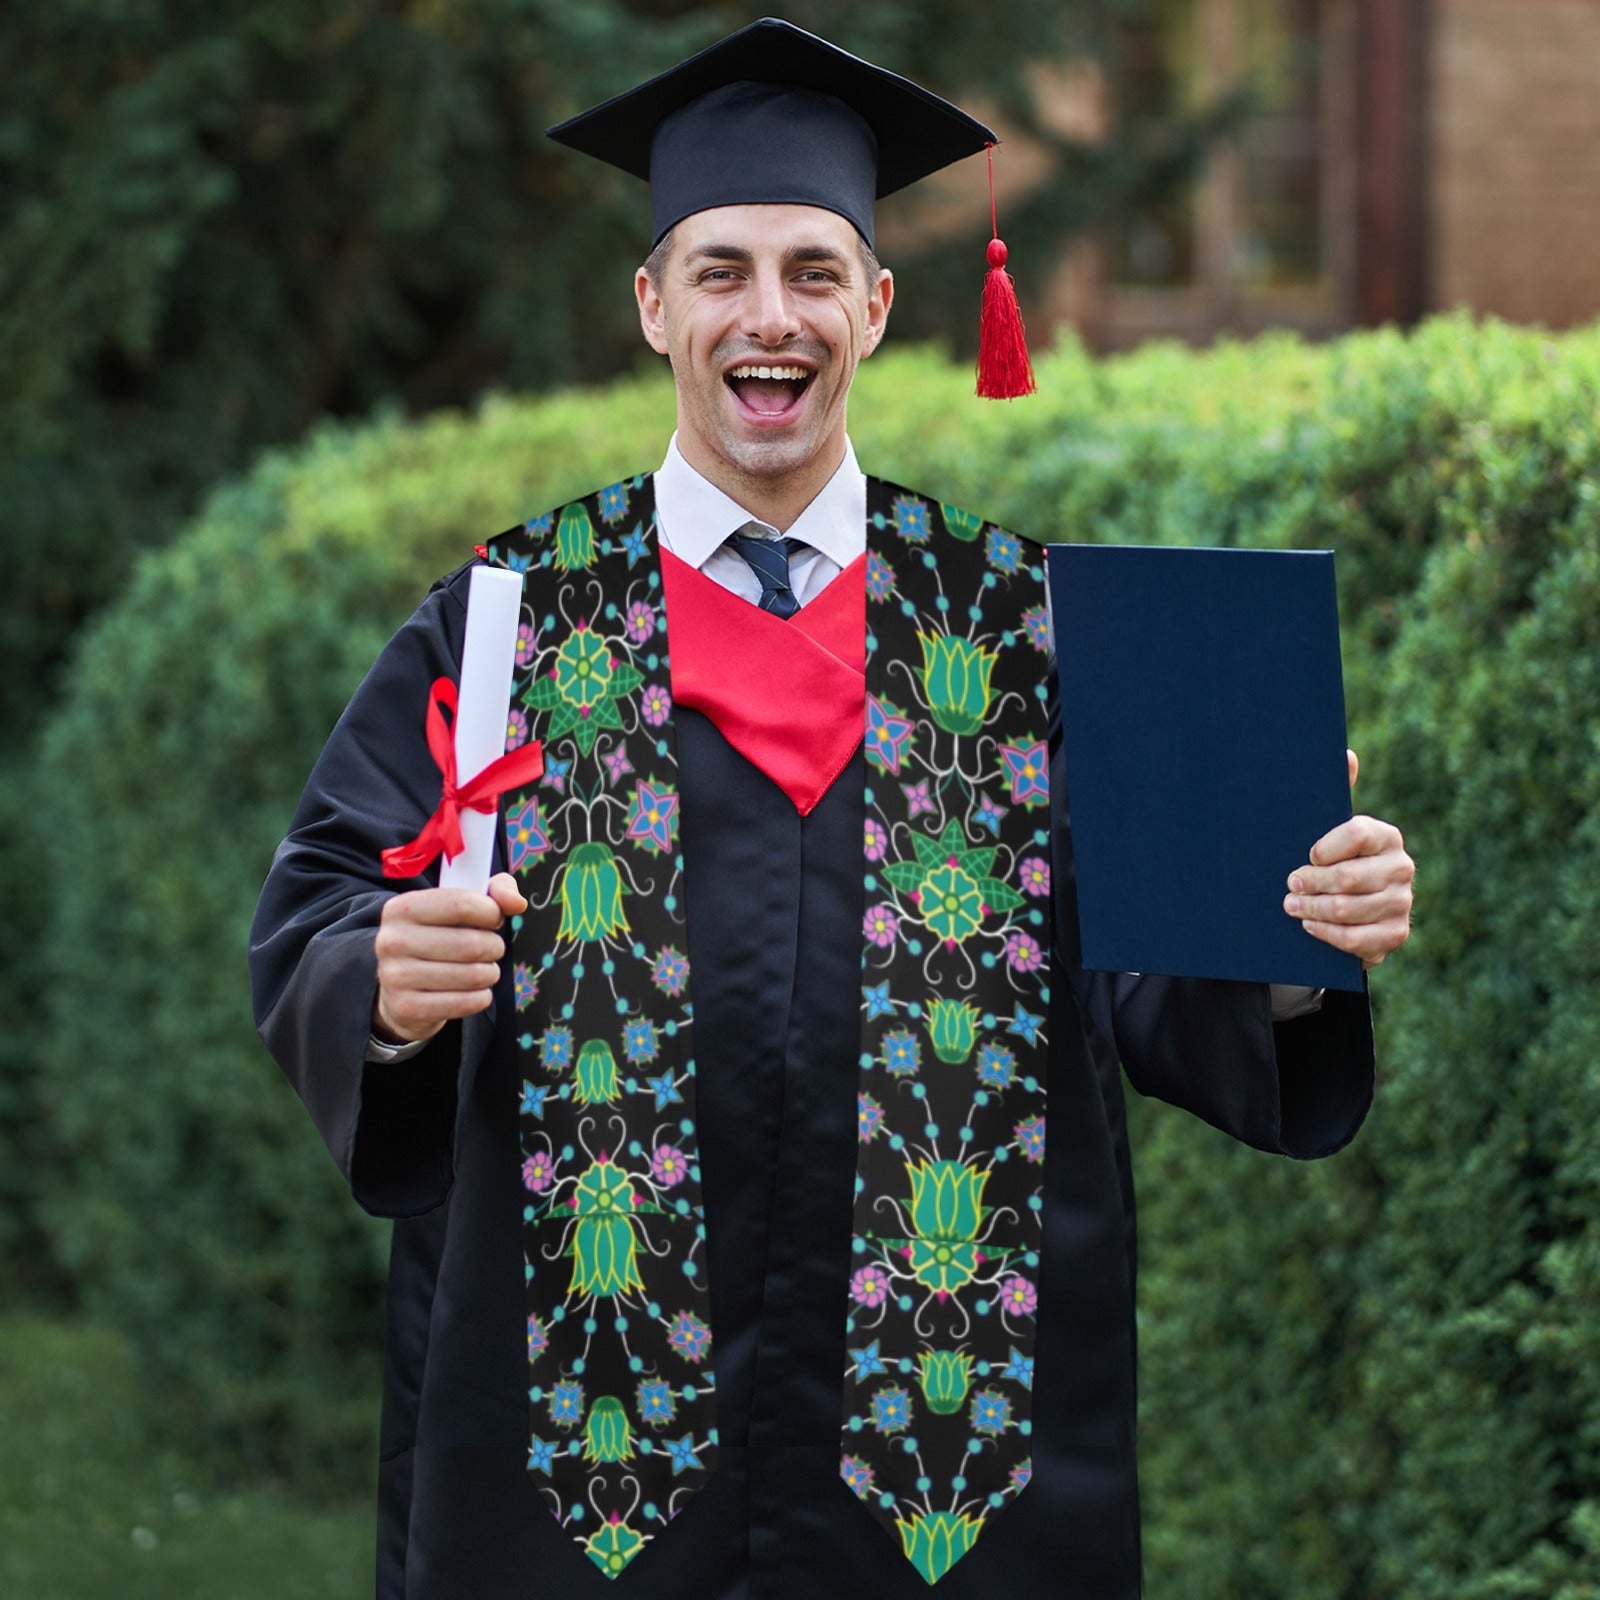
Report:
1035,0,1600,349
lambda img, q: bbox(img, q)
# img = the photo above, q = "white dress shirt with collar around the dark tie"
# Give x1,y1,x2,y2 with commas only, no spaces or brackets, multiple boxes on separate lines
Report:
366,434,1322,1061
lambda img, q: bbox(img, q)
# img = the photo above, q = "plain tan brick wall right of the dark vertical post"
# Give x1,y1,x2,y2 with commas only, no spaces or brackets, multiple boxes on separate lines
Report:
1429,0,1600,326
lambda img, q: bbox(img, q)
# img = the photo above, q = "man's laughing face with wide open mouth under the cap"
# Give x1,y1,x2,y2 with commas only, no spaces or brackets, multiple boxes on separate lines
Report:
635,205,894,488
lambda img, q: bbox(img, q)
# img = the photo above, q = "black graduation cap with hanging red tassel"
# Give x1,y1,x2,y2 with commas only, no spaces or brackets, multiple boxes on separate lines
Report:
549,18,1034,397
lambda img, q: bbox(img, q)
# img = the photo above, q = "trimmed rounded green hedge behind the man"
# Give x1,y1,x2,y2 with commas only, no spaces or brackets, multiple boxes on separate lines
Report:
31,320,1600,1600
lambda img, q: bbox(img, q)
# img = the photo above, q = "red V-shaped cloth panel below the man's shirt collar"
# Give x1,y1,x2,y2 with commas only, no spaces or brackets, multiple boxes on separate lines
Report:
661,550,867,816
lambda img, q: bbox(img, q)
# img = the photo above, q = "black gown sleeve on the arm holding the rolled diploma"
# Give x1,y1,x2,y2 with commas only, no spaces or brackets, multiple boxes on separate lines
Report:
250,566,491,1216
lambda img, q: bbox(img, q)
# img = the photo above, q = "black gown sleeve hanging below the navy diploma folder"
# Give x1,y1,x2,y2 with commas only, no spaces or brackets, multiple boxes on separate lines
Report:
1050,678,1374,1160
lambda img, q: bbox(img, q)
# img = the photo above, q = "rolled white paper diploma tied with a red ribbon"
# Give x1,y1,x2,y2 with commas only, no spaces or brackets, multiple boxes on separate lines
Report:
438,566,522,894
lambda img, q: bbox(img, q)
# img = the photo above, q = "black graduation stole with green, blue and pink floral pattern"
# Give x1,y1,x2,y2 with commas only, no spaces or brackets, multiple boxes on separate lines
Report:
490,475,1050,1582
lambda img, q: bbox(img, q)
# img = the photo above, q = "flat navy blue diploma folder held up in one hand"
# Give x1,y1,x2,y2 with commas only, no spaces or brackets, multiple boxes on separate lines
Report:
1050,544,1362,989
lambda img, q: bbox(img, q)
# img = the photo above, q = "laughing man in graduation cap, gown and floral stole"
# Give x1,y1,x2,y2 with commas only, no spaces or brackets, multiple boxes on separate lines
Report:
253,22,1411,1600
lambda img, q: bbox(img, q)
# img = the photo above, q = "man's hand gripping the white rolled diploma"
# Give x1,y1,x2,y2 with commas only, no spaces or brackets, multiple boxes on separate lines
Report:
373,872,528,1043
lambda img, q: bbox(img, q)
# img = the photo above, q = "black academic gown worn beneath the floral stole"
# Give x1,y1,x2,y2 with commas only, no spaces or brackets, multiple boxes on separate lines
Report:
251,553,1373,1600
